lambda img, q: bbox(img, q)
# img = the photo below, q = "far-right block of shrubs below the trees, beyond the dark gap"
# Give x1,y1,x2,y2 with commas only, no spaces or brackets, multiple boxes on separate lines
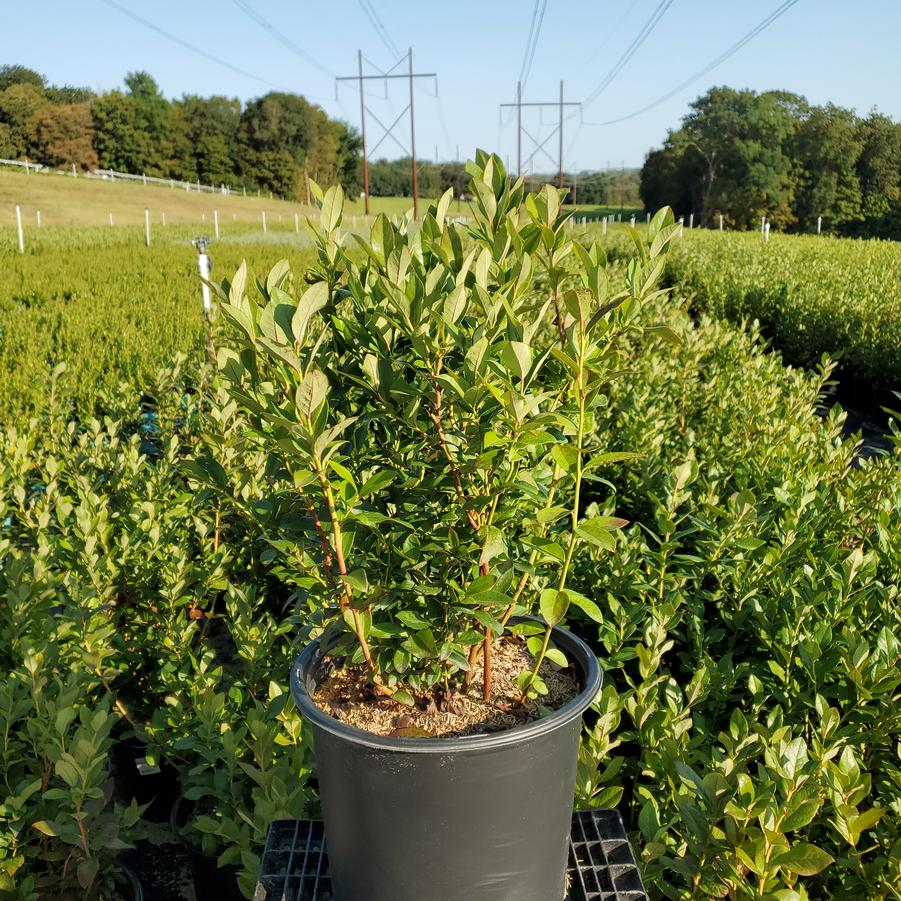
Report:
652,230,901,398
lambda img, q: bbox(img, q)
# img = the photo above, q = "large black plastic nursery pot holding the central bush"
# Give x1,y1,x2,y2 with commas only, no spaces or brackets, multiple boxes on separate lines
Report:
291,628,601,901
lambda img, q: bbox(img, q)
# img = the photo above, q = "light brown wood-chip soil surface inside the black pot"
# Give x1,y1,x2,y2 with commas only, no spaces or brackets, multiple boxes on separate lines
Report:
313,636,581,738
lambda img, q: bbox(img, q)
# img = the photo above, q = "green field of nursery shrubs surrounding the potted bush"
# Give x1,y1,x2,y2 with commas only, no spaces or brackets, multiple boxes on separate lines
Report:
0,190,901,901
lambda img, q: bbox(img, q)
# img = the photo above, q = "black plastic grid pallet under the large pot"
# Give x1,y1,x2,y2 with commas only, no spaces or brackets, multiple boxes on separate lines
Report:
254,810,648,901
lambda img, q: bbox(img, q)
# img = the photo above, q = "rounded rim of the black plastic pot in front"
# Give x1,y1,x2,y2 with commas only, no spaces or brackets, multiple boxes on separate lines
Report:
290,616,603,754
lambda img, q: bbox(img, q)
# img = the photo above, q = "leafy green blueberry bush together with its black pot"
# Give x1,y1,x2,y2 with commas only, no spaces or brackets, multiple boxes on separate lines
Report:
218,152,676,901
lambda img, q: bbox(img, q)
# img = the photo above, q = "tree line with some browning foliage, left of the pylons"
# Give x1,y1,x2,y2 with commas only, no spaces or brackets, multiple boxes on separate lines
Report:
0,65,360,199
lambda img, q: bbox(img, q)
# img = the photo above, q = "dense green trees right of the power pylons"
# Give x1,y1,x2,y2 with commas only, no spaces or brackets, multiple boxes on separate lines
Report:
640,87,901,239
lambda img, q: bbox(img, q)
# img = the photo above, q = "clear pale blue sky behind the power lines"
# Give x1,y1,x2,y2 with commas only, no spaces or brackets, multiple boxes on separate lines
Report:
0,0,901,171
